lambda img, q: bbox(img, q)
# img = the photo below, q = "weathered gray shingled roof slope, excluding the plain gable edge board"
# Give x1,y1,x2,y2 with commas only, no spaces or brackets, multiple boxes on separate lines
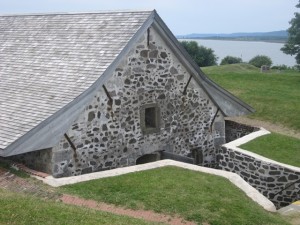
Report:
0,11,152,149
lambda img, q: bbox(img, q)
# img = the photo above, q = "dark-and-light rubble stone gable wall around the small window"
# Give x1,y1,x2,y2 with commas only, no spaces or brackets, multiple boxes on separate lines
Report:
53,26,225,177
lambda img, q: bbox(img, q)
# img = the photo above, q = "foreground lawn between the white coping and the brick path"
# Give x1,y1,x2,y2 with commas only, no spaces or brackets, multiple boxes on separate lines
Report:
61,167,287,225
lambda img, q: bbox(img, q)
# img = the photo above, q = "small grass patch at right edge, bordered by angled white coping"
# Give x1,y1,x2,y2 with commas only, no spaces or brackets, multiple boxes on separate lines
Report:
240,133,300,167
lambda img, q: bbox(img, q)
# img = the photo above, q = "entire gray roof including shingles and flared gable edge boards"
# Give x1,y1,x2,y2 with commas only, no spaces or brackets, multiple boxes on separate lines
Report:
0,10,253,156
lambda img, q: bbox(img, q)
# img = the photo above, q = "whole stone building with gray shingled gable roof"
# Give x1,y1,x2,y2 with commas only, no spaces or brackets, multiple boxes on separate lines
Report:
0,11,253,177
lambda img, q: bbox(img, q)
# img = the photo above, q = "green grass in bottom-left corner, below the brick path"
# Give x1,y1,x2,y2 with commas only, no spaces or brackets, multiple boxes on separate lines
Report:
0,189,153,225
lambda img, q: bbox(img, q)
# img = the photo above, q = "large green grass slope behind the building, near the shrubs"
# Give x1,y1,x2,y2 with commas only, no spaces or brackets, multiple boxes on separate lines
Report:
202,64,300,131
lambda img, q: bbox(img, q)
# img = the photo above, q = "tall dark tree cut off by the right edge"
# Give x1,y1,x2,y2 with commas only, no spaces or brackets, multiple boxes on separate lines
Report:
281,0,300,66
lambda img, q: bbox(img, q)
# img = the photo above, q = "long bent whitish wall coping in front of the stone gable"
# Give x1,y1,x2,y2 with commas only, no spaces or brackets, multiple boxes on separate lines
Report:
37,160,276,212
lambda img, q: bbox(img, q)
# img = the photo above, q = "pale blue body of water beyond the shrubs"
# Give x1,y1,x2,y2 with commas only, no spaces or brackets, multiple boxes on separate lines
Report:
180,39,296,66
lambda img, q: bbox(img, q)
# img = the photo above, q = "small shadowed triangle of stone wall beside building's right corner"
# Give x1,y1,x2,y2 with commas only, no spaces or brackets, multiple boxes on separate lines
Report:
225,120,259,143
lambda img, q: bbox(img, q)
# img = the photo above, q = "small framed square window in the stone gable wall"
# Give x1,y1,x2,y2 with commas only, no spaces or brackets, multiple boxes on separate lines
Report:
140,103,160,134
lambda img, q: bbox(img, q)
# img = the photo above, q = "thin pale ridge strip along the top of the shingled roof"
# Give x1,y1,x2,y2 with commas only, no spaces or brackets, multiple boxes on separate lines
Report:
0,9,155,17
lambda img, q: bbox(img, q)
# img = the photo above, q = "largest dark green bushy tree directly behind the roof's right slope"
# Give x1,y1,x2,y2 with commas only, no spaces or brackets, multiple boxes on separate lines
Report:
181,41,218,67
